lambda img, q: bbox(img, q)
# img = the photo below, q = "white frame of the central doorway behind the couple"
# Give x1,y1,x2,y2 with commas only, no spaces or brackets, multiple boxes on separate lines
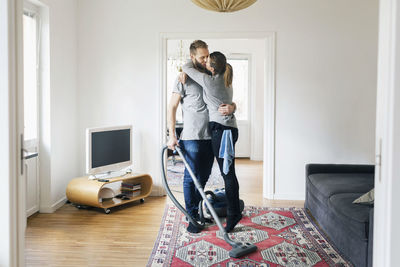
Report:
156,31,276,199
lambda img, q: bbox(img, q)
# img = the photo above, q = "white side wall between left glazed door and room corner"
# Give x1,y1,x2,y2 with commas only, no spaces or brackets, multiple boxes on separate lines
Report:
40,0,79,212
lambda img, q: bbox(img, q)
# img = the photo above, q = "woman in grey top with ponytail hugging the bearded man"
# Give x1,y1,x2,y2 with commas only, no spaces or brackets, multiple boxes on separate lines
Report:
183,52,242,233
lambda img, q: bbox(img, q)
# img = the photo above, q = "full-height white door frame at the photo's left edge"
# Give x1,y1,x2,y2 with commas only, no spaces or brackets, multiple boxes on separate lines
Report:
0,0,26,266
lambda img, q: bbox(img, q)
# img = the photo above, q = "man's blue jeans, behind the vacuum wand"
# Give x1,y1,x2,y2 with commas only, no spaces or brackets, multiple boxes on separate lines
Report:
179,140,214,218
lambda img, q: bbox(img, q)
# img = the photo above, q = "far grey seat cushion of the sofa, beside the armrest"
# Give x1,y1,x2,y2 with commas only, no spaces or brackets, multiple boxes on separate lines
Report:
307,173,374,205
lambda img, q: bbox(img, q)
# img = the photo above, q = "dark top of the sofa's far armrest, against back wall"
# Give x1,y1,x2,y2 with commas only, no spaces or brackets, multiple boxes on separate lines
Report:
306,163,375,177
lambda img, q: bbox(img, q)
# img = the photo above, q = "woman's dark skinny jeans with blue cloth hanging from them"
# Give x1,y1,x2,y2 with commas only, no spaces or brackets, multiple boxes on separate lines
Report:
209,121,241,216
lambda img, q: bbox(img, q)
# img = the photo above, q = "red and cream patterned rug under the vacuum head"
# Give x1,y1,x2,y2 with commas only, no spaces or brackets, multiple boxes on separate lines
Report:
147,205,353,267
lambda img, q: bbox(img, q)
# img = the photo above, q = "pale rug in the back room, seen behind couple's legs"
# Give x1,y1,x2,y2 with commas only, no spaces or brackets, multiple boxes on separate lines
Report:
167,157,224,188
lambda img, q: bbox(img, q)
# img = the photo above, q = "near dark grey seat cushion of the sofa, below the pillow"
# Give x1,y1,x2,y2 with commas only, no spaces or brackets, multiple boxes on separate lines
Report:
329,193,371,240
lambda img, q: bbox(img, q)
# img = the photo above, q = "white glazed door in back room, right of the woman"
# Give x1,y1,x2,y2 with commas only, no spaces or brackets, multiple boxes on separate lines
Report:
227,54,251,158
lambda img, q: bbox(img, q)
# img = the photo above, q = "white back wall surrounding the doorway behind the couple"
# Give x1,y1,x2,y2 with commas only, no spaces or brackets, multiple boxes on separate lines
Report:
78,0,378,199
